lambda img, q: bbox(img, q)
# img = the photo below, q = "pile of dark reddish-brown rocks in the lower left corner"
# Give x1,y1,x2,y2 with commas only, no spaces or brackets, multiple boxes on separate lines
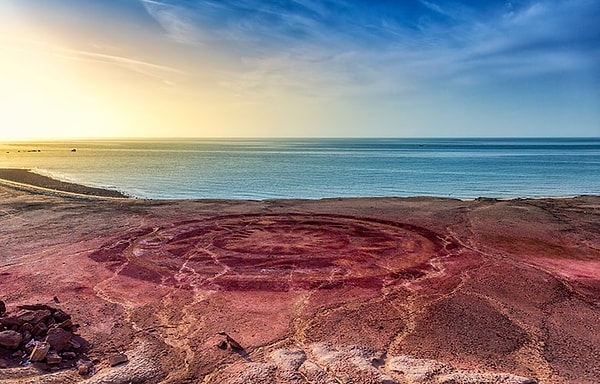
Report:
0,300,91,375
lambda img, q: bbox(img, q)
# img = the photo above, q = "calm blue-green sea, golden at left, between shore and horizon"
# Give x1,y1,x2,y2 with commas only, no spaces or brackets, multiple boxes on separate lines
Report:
0,138,600,199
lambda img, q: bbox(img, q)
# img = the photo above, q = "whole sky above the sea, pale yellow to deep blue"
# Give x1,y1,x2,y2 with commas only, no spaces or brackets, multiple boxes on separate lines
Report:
0,0,600,140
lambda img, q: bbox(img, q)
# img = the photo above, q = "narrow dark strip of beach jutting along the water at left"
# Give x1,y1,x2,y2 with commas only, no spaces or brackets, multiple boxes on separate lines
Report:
0,168,129,198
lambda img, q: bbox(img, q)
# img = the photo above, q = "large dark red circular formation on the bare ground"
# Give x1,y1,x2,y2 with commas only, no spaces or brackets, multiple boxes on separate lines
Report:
91,214,449,291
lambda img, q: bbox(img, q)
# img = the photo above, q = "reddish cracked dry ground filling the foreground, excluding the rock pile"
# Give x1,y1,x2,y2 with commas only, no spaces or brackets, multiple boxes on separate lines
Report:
0,184,600,384
